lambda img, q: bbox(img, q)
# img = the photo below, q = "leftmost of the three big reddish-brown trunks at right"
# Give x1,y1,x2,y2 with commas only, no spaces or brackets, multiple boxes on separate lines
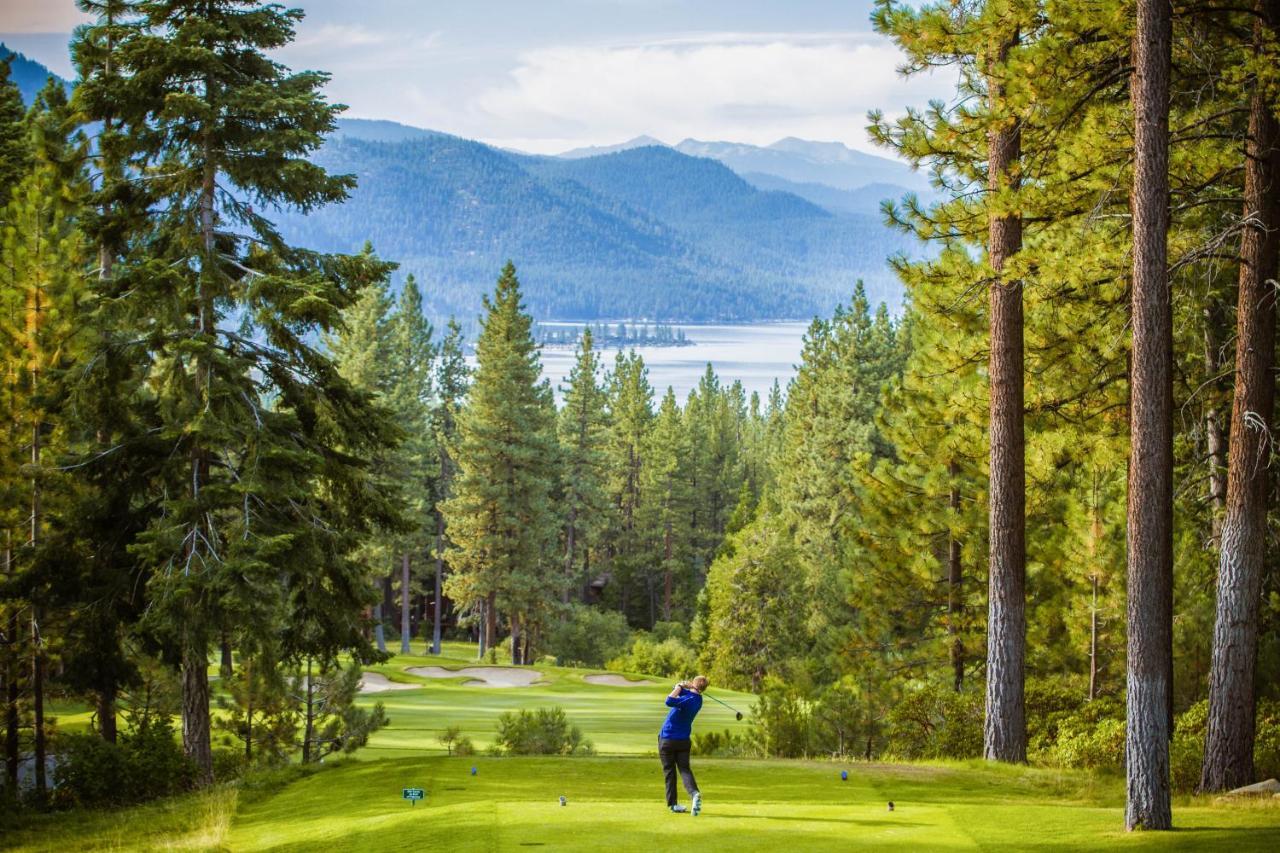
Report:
983,29,1027,762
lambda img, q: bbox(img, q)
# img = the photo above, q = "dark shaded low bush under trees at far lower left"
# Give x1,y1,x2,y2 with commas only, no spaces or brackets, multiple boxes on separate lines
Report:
54,717,195,807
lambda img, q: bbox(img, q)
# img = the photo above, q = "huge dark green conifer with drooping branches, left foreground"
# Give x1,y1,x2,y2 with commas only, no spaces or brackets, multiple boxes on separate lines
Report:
102,0,392,784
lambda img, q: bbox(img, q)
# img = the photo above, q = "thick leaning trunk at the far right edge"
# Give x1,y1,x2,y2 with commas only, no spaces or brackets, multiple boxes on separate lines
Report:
1201,0,1280,792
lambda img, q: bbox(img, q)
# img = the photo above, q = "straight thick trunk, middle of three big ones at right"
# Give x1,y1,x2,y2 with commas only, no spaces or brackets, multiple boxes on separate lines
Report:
1125,0,1174,830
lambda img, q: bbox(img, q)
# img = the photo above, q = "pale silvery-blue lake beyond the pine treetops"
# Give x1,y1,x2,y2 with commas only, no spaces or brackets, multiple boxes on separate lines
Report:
529,323,809,406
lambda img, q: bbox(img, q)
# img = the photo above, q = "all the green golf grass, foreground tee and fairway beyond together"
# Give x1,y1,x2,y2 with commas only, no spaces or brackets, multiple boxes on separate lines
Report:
12,646,1280,853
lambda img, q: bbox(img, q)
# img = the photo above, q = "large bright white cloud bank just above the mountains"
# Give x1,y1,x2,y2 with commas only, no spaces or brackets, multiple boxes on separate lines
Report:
471,33,948,150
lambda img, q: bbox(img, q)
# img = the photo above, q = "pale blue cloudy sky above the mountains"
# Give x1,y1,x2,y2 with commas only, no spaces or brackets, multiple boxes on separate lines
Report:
0,0,948,152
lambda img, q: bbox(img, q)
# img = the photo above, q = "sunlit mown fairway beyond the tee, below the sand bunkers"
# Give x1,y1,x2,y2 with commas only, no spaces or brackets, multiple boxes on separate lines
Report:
357,642,755,760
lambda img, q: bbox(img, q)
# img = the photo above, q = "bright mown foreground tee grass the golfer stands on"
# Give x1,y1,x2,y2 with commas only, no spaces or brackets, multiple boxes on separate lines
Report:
227,757,1280,853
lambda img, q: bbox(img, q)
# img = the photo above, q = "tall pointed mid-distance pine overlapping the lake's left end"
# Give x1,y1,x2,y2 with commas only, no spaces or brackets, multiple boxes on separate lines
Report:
444,261,558,663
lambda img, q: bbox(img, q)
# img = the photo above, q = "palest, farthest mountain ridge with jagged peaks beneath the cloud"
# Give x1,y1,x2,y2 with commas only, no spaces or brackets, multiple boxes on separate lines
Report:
676,138,928,191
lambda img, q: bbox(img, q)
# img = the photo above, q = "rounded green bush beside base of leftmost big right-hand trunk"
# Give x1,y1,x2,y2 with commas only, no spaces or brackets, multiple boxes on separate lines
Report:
886,684,983,760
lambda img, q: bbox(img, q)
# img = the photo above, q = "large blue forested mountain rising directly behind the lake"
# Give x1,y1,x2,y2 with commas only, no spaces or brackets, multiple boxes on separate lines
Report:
279,133,911,320
